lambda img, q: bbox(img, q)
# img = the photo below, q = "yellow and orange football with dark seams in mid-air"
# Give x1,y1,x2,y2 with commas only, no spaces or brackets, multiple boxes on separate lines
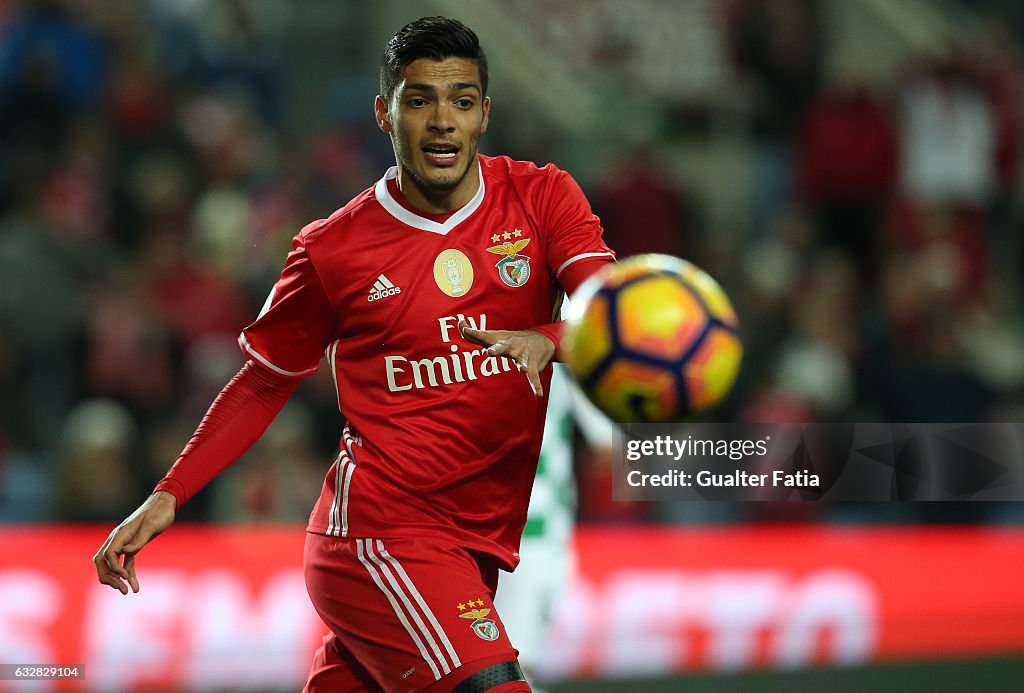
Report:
562,254,742,423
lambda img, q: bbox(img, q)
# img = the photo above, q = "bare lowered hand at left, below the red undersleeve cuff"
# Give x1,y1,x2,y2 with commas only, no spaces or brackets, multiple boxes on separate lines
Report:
92,491,176,595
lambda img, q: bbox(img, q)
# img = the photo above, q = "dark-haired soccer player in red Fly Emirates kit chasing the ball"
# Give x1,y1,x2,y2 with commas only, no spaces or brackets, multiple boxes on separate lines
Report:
94,17,613,693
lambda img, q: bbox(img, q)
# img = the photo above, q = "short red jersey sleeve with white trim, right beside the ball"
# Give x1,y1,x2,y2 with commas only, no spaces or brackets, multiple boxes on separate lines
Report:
542,169,615,280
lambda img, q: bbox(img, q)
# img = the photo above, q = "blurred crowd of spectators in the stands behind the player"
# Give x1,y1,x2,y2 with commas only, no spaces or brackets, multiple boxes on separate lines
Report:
0,0,1024,522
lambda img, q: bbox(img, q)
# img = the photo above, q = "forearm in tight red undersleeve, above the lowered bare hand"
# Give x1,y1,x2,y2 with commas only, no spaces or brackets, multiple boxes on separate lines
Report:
155,361,299,509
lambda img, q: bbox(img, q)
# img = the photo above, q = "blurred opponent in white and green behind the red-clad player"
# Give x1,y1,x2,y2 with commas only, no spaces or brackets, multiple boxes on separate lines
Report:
495,363,612,691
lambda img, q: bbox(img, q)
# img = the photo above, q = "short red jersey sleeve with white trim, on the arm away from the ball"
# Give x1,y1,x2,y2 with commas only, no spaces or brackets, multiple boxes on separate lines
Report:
239,235,337,378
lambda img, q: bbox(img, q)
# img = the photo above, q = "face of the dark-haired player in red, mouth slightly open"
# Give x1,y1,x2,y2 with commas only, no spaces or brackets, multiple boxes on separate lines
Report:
376,57,490,209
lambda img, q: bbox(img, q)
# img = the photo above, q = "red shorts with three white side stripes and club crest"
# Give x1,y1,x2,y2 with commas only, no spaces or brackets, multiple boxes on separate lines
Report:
304,533,530,693
